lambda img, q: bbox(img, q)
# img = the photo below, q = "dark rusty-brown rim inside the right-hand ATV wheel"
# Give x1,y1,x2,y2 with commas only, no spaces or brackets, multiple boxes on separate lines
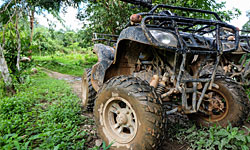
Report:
200,89,229,122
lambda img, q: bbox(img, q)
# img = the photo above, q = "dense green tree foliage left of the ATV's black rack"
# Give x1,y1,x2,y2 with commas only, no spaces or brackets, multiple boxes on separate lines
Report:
78,0,144,34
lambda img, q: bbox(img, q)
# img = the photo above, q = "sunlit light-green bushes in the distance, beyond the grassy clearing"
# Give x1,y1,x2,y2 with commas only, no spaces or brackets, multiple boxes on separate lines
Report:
32,25,92,56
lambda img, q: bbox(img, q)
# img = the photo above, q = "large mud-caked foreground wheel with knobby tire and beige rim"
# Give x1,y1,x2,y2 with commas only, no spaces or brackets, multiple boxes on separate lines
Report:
94,76,166,150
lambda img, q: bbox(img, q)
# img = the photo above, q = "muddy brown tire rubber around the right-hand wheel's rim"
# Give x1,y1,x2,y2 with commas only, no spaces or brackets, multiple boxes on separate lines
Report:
188,78,250,127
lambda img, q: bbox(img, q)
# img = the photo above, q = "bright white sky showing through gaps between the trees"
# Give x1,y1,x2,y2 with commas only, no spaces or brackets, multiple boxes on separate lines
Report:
0,0,250,31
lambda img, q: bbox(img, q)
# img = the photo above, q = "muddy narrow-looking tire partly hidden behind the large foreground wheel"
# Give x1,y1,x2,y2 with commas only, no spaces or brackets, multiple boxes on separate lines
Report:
81,68,96,112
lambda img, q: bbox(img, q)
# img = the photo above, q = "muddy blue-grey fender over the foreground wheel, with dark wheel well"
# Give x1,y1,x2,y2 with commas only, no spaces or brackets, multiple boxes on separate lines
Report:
91,26,153,91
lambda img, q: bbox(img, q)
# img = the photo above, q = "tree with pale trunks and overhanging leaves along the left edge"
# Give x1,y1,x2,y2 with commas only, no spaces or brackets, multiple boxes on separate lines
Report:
0,0,81,93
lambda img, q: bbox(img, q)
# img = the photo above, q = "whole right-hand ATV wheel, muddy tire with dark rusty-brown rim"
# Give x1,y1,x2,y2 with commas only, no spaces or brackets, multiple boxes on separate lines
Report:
188,79,249,127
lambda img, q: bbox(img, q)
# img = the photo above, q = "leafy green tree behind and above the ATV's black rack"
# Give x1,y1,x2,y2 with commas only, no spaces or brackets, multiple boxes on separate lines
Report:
78,0,240,40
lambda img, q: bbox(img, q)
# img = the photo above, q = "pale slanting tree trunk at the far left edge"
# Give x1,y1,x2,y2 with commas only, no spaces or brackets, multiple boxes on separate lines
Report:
0,45,15,94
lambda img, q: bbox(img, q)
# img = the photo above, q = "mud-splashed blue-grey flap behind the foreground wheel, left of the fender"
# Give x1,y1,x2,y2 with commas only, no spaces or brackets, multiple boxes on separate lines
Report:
91,44,115,91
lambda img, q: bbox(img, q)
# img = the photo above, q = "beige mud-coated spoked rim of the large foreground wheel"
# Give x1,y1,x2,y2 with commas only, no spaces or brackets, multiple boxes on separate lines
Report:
102,97,138,143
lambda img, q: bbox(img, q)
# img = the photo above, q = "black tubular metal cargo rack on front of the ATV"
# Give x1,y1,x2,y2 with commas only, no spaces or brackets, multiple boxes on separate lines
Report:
135,5,240,54
